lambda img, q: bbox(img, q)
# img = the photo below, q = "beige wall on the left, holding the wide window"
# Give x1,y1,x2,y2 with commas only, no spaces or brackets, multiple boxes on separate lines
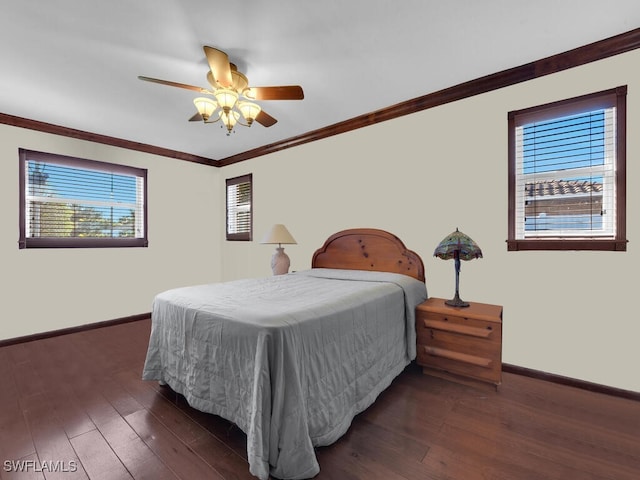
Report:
0,125,224,339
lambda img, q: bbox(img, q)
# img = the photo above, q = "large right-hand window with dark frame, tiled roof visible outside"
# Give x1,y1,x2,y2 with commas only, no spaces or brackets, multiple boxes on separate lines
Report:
507,87,627,250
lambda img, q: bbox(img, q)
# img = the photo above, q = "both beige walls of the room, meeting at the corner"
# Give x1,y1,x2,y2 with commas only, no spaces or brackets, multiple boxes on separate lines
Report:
0,47,640,391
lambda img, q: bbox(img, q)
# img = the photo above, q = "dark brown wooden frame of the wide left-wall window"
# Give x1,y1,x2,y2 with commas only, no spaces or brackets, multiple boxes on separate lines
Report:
18,148,149,249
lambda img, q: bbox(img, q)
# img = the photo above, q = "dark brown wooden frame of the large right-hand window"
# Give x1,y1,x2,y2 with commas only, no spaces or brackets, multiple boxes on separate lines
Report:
507,85,627,251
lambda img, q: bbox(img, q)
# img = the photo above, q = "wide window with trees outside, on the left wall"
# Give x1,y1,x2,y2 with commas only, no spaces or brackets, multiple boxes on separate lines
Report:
18,149,148,248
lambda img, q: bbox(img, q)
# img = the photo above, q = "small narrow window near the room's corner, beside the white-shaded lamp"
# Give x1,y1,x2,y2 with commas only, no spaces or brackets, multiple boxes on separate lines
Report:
227,174,253,241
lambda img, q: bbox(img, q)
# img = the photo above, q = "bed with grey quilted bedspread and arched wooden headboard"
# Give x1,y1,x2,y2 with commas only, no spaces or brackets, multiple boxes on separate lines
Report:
142,229,427,480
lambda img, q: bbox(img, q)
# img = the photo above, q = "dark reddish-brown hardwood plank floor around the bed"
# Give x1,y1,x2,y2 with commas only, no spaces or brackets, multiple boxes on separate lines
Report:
0,320,640,480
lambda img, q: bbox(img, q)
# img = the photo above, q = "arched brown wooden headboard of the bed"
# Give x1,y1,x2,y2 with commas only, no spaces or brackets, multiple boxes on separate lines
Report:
311,228,424,282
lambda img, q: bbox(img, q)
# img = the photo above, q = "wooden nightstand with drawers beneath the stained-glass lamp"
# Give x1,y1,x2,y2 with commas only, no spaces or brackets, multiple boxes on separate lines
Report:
416,298,502,389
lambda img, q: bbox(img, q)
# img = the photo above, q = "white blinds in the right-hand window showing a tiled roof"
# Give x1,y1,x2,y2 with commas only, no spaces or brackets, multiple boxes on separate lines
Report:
515,107,616,239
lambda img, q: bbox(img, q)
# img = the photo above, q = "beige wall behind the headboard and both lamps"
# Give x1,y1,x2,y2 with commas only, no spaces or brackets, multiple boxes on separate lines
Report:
219,50,640,391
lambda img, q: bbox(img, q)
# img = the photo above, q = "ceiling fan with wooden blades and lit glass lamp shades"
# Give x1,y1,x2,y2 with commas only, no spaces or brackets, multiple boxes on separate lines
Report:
138,46,304,135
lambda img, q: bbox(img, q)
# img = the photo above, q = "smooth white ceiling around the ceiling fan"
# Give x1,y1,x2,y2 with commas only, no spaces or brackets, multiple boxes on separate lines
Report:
0,0,640,160
